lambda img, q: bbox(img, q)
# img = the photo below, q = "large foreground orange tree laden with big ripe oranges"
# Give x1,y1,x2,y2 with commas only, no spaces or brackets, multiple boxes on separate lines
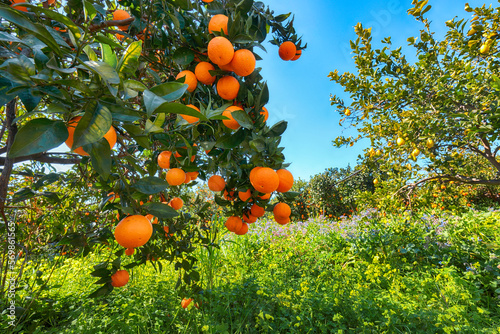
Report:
0,0,305,296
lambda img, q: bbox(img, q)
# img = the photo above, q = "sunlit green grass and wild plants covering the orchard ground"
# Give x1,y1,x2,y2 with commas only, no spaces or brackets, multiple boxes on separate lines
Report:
3,211,500,333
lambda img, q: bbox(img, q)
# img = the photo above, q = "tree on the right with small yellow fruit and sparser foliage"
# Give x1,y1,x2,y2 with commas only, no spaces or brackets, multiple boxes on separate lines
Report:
329,0,500,206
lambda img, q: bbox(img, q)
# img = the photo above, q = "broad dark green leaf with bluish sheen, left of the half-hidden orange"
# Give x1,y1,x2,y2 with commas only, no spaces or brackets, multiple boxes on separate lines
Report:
9,118,68,158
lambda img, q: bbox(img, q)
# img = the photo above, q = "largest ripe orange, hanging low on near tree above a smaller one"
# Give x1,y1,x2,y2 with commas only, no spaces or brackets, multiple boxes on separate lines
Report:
115,215,153,248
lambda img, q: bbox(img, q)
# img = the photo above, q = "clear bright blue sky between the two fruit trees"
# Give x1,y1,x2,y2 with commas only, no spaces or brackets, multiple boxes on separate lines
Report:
257,0,496,180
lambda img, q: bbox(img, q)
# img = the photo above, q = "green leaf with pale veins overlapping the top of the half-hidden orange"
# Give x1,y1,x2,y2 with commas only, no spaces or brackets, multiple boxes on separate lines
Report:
71,104,112,150
